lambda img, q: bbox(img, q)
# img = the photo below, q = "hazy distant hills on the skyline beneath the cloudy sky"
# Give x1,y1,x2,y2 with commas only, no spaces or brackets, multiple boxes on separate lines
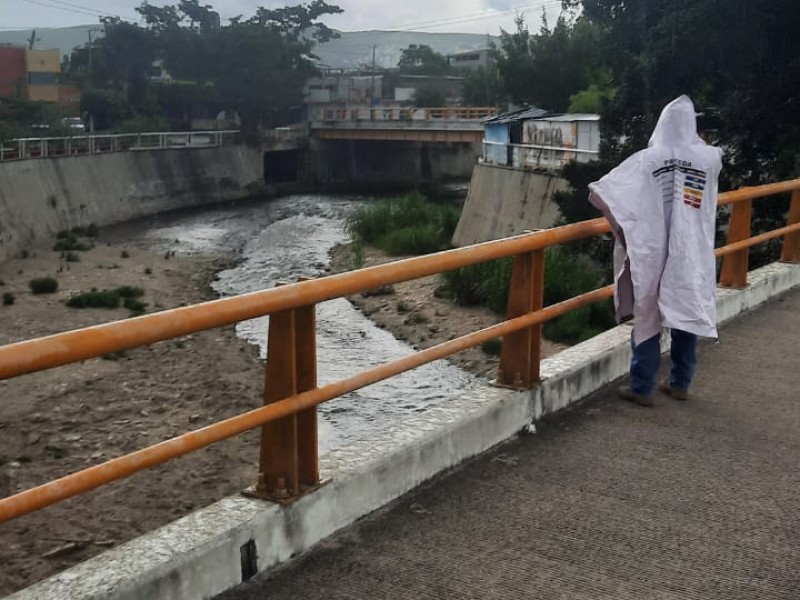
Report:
0,25,490,69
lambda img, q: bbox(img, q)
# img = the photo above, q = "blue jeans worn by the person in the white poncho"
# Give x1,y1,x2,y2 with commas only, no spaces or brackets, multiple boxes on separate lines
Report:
631,329,697,396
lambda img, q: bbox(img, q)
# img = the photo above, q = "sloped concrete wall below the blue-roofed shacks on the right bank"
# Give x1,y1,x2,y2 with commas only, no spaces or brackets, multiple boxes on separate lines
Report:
453,164,568,246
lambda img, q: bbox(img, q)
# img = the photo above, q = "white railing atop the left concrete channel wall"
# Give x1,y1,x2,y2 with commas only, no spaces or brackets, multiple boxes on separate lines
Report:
0,130,239,162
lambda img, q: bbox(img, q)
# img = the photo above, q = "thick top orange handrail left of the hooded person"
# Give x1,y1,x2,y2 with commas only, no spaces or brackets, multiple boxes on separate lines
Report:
0,219,610,381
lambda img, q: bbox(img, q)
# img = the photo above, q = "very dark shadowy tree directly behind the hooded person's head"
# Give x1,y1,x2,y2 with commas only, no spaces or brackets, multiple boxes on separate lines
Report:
572,0,800,186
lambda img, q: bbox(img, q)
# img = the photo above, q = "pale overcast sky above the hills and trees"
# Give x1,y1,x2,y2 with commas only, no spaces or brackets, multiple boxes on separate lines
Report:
0,0,561,35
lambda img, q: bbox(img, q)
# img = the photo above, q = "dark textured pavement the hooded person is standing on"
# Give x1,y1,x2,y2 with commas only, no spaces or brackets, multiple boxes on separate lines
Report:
218,291,800,600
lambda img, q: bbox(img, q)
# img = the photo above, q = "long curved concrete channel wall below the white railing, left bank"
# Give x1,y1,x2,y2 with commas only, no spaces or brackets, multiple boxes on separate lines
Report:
0,146,263,260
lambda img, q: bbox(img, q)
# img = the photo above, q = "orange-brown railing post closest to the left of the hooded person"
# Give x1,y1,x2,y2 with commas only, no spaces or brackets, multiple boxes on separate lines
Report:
497,250,544,388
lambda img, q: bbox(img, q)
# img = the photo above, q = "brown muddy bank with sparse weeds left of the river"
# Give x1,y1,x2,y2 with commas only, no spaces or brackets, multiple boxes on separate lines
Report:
0,238,263,596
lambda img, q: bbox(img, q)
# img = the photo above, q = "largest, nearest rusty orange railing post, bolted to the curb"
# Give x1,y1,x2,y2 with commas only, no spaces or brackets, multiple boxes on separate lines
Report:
256,298,319,503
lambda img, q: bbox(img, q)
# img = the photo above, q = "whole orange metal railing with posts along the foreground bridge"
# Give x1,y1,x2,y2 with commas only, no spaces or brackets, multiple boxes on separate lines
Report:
0,180,800,522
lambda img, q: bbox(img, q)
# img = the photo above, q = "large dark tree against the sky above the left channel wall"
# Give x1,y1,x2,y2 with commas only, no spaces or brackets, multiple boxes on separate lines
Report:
71,0,342,138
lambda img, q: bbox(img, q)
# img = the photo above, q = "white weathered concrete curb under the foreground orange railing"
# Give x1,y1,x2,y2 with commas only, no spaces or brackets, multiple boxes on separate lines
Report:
9,263,800,600
